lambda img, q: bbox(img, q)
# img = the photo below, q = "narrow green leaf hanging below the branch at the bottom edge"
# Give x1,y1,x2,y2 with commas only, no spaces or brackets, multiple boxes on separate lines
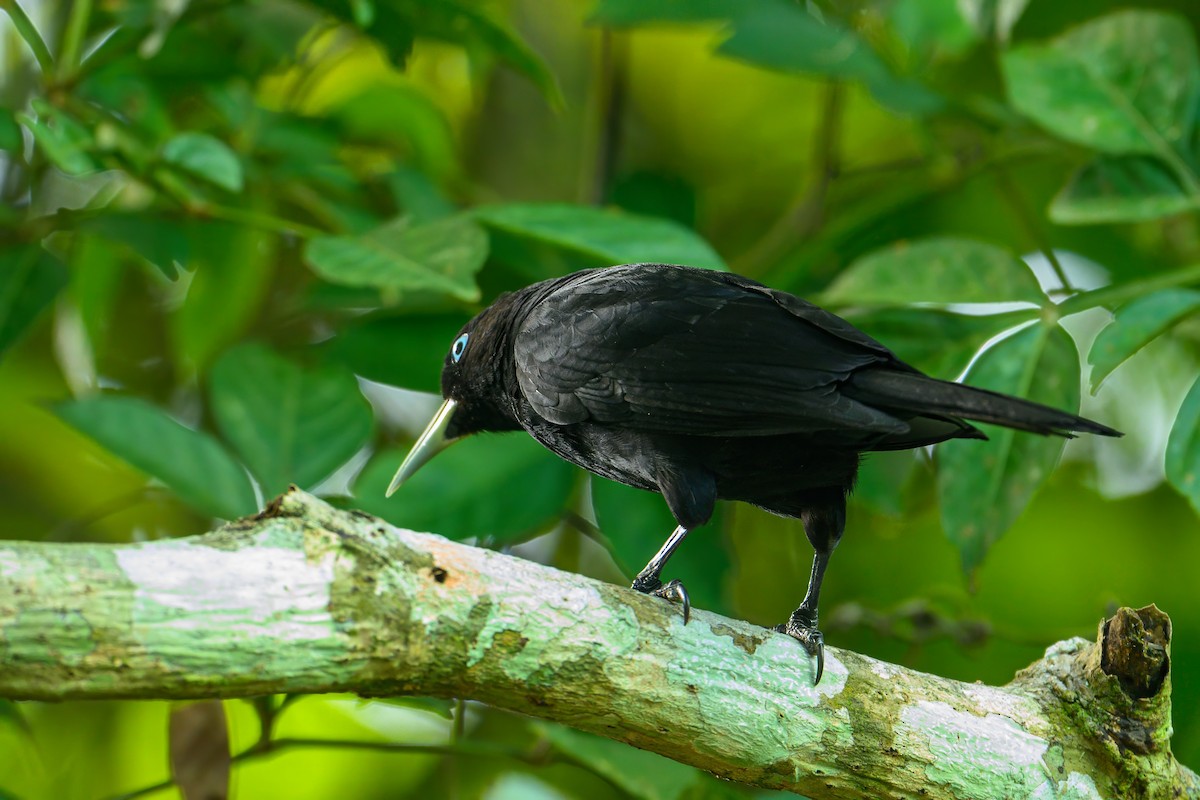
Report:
538,724,703,800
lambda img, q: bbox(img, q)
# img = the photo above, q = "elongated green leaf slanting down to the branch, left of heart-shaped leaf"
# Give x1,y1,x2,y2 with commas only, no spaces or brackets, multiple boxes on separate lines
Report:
55,395,257,519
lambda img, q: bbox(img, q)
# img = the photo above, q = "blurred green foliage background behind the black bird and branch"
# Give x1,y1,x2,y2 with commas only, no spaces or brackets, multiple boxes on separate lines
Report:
0,0,1200,799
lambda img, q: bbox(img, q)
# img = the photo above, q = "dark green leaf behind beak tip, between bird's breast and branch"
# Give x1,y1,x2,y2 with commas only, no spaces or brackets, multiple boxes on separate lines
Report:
354,433,576,542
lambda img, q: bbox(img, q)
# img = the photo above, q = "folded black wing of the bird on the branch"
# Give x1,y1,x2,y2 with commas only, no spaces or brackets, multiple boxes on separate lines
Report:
514,265,908,438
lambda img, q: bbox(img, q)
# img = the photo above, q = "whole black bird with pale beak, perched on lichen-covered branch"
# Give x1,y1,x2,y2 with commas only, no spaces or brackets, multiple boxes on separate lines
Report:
388,264,1121,682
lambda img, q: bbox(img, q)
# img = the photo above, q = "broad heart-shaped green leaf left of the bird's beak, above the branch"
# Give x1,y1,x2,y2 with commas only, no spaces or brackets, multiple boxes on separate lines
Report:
209,344,372,497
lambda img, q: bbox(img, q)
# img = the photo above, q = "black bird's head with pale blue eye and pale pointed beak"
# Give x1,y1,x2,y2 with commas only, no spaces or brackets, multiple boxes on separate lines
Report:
388,295,521,497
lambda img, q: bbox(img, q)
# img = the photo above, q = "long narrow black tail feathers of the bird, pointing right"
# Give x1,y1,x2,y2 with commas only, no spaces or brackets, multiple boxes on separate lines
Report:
846,369,1123,438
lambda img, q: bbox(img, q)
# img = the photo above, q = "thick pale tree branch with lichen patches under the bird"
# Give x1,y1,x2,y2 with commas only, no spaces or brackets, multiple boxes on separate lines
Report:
0,491,1200,800
